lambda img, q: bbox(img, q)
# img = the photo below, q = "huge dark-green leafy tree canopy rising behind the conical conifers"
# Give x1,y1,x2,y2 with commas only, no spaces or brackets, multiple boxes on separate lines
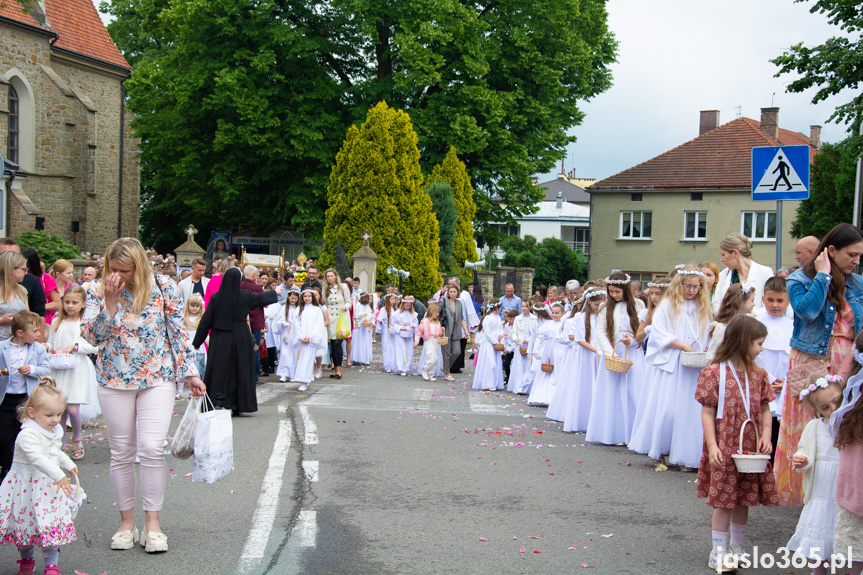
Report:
102,0,617,242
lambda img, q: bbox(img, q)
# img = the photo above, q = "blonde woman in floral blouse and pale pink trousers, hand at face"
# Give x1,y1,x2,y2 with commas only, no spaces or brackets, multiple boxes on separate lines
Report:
81,238,205,553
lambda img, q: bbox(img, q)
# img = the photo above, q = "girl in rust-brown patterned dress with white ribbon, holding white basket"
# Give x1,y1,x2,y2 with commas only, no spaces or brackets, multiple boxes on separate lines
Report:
695,315,779,573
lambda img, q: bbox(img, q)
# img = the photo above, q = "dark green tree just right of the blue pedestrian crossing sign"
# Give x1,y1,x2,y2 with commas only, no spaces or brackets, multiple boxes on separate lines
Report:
791,140,857,238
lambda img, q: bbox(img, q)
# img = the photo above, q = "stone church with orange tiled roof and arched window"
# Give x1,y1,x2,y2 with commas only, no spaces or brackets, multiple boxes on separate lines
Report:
0,0,140,253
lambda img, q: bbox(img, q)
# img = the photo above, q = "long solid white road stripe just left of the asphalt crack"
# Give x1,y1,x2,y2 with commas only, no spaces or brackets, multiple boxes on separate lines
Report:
239,405,293,573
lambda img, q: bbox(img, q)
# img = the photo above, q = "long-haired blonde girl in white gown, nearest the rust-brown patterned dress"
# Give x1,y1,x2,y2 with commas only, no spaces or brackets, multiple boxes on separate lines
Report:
630,266,712,470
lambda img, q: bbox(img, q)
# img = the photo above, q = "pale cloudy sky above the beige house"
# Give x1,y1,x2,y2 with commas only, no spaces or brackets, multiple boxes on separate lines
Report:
93,0,853,182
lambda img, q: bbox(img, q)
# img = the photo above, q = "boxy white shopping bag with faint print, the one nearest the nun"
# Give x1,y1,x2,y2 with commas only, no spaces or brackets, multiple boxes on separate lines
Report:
192,396,234,483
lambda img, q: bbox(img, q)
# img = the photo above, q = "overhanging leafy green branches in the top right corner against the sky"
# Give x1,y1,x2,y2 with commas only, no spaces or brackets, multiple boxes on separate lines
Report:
771,0,863,128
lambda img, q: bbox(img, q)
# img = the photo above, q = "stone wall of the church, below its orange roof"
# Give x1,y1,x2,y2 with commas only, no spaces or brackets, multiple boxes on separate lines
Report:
0,23,140,253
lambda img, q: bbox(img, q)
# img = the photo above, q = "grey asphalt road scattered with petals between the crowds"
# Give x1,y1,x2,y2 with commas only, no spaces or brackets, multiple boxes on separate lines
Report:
0,346,808,575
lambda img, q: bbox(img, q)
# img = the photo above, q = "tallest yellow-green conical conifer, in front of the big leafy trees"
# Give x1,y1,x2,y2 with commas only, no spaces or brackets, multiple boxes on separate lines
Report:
320,102,440,298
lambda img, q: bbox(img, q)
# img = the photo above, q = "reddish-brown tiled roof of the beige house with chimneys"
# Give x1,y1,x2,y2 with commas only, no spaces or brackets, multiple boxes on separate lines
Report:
587,118,817,192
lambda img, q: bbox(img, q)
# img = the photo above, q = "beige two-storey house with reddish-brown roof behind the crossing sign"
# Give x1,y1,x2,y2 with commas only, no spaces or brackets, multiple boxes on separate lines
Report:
587,108,821,280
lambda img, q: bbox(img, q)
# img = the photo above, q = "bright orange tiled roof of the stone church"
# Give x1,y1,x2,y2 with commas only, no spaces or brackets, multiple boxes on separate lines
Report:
0,0,130,68
